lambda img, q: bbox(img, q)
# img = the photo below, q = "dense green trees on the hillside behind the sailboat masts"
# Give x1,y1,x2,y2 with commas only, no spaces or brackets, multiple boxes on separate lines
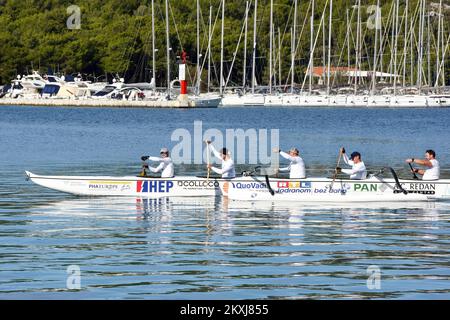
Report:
0,0,450,86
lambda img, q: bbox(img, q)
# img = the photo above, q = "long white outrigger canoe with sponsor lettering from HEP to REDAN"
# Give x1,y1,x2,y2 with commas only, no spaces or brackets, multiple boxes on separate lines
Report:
26,171,450,202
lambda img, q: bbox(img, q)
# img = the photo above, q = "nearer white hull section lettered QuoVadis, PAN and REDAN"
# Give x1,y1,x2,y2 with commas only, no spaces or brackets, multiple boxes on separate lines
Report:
227,177,450,202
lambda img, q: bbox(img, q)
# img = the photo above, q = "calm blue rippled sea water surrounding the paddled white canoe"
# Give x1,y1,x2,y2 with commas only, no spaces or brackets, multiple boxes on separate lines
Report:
0,107,450,299
